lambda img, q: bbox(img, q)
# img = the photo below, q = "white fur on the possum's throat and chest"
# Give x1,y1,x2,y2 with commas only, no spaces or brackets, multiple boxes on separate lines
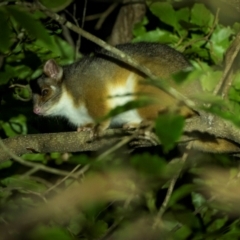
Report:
48,91,94,127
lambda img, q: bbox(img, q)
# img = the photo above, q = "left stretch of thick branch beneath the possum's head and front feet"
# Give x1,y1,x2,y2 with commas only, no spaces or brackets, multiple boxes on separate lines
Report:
0,130,119,162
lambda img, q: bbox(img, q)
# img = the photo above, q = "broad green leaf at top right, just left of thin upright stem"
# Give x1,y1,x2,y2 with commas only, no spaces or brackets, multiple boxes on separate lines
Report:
190,3,214,33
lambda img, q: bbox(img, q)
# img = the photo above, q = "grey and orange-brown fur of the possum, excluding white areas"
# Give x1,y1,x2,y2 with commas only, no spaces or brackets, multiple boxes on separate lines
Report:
31,43,201,128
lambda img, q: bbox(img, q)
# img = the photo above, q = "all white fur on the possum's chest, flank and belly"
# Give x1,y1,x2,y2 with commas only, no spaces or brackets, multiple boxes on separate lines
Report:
48,73,142,127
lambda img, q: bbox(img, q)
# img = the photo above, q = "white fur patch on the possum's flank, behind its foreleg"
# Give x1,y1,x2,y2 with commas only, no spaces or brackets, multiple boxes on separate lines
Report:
108,73,142,127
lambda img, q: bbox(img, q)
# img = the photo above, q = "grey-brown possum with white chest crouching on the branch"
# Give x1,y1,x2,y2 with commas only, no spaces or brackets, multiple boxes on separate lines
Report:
32,42,200,135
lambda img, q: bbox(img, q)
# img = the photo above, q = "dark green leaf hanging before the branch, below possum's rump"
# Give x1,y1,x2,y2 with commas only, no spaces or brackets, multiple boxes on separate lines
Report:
156,113,184,152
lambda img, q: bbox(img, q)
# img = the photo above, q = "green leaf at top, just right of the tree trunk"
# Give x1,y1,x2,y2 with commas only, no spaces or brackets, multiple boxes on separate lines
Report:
149,2,180,30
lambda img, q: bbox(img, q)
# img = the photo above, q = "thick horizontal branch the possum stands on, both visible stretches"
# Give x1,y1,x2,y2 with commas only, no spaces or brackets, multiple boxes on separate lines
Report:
0,114,240,162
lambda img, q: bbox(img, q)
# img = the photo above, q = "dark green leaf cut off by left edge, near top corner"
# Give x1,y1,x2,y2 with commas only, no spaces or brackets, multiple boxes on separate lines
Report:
0,9,12,53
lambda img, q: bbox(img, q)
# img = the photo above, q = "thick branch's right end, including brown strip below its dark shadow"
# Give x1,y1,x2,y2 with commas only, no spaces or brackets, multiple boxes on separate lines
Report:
184,113,240,153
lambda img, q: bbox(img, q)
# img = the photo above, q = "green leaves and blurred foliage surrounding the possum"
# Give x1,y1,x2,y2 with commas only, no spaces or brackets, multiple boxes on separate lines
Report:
0,0,240,240
